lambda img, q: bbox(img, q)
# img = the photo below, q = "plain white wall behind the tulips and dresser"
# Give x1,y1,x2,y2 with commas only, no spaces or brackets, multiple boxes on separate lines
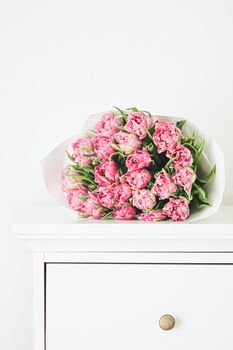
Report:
0,0,233,350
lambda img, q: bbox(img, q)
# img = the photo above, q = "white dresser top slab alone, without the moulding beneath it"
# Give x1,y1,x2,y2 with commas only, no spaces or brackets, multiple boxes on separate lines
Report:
13,204,233,238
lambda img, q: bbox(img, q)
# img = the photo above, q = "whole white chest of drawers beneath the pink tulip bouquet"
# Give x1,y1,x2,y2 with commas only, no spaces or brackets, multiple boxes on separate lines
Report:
14,206,233,350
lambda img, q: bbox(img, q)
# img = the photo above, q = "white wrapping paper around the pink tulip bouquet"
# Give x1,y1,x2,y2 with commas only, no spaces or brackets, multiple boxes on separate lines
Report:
41,112,225,222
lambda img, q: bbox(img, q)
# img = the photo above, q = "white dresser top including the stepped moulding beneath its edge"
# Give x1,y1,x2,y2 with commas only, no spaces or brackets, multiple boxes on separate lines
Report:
13,204,233,252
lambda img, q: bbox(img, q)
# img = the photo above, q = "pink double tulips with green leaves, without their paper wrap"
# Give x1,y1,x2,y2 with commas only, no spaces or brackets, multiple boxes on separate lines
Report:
62,108,216,221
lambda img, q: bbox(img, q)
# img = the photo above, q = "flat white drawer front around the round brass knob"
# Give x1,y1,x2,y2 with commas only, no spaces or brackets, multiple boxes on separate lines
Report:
46,263,233,350
